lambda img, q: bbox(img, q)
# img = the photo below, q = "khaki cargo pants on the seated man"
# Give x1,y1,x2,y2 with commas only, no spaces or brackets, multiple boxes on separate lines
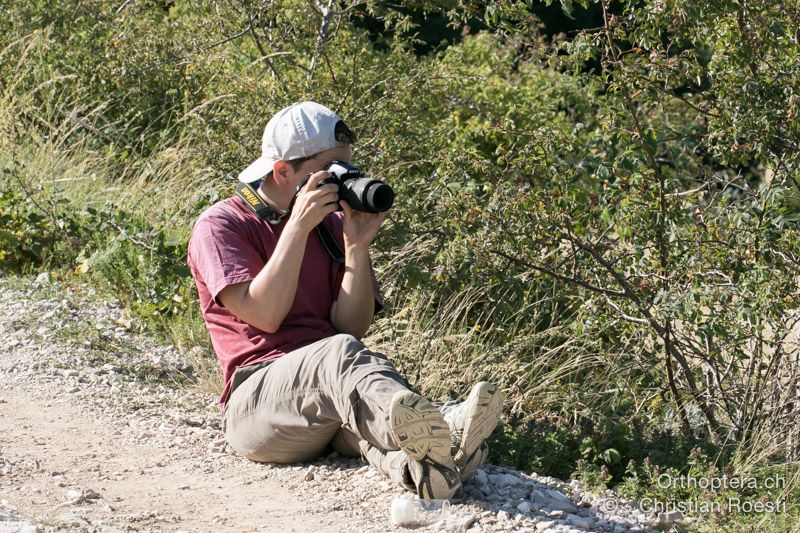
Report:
222,335,414,490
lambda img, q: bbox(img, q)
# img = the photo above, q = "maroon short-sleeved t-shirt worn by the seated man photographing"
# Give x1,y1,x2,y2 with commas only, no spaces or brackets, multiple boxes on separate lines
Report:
188,196,383,408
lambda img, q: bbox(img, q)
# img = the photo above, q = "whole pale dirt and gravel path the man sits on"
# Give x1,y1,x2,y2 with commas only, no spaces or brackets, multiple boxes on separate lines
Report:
0,278,655,533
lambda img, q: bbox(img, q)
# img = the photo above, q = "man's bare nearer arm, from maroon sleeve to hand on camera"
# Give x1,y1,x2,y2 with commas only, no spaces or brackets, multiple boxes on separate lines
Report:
218,172,338,333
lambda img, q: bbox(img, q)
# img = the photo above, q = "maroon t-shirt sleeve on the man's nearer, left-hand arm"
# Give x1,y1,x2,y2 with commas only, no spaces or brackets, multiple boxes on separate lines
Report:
189,211,266,305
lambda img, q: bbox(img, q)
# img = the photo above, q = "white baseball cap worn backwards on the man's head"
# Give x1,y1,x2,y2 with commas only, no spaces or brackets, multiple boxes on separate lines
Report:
234,102,356,183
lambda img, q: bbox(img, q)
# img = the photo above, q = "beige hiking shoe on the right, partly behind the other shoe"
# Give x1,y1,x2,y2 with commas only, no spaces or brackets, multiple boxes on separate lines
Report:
439,381,503,478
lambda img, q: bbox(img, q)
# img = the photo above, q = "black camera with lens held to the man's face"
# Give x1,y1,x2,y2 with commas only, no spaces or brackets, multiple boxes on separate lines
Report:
319,160,394,213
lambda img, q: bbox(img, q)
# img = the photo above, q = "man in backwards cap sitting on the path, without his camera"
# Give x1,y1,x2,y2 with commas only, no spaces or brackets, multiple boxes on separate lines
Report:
188,102,502,499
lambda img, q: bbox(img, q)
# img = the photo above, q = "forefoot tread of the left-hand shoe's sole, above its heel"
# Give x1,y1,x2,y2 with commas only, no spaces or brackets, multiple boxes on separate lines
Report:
389,391,455,469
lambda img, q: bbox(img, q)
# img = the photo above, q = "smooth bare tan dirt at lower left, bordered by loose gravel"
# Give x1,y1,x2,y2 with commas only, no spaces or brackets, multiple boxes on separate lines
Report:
0,387,338,531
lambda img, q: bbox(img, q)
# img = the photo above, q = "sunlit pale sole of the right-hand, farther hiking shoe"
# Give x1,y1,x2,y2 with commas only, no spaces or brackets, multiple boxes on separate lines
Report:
455,381,503,467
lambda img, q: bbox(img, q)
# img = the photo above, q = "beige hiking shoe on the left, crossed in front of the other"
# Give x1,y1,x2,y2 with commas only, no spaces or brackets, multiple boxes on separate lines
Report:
389,391,461,500
